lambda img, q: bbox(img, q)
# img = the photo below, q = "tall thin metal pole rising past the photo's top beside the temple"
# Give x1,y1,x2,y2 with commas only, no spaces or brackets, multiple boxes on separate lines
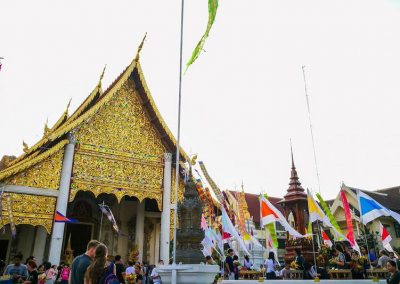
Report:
171,0,185,284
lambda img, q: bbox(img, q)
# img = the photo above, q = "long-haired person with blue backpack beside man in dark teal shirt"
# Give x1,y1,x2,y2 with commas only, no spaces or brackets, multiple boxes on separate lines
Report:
84,244,119,284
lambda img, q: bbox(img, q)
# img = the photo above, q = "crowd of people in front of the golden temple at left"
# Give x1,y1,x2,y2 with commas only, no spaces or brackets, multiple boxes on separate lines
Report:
0,240,163,284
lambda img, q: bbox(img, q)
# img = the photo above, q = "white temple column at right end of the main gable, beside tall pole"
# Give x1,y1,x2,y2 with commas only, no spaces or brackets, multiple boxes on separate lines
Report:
157,153,172,264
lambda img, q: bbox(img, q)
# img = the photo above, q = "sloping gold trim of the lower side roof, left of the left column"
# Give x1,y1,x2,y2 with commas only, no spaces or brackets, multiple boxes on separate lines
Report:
0,140,68,180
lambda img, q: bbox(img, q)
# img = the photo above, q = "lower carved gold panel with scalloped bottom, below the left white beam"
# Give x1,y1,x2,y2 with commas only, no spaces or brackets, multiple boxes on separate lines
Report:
0,193,56,234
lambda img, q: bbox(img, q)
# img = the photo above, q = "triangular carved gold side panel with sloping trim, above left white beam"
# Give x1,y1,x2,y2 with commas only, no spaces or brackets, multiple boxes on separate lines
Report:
0,140,68,189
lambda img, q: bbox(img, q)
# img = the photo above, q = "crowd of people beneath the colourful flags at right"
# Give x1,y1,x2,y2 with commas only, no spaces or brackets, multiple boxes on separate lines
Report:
206,242,400,284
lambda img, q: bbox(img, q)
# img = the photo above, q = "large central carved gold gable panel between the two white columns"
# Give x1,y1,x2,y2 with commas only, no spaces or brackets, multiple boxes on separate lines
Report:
70,79,167,208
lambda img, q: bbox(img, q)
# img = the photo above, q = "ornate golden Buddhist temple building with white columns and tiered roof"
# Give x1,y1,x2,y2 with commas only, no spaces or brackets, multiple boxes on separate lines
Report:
0,42,188,264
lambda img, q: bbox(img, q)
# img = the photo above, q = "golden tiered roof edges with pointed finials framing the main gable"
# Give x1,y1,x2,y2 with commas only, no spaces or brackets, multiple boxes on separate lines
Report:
0,37,190,180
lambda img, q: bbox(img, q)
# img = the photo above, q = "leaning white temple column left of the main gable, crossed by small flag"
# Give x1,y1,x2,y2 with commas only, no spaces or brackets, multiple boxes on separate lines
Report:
49,133,75,264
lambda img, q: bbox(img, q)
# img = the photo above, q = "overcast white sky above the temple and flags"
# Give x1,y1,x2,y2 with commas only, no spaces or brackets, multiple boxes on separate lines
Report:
0,0,400,198
